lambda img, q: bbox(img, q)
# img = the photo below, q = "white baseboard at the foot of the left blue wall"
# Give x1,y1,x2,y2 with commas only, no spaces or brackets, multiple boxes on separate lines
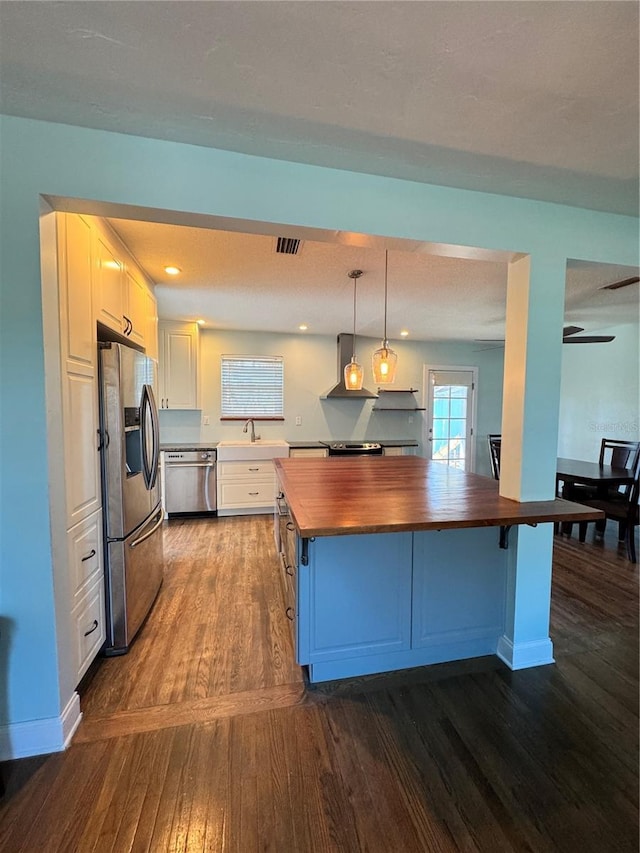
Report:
0,692,82,761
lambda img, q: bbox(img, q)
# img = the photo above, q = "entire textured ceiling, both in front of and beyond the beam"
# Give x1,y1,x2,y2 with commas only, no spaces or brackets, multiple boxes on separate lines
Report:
0,0,639,340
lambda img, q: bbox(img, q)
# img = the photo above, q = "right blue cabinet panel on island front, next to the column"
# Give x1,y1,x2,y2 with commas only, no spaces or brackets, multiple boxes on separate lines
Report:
411,527,507,663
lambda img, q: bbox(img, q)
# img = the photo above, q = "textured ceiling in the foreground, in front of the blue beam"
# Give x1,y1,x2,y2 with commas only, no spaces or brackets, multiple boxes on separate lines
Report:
0,0,638,212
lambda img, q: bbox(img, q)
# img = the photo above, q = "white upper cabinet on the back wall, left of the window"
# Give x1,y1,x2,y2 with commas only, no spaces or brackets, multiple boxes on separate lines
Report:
158,323,200,409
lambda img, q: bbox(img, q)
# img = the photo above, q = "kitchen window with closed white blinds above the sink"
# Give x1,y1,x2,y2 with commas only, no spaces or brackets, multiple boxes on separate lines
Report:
220,355,284,420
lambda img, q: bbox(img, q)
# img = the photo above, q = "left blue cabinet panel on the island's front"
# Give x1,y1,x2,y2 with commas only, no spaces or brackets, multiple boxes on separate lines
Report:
297,533,412,664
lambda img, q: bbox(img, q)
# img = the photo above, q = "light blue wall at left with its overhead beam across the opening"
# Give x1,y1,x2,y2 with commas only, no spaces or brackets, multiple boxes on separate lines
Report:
0,117,638,736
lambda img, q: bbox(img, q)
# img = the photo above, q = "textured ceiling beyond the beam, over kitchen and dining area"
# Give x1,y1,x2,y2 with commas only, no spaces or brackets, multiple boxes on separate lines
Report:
109,219,639,341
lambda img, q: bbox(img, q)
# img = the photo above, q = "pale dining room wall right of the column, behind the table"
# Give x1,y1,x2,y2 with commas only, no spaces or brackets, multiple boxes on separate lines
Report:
558,322,640,462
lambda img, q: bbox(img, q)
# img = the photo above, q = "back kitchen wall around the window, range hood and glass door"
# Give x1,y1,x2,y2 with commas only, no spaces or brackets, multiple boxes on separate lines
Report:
160,330,504,474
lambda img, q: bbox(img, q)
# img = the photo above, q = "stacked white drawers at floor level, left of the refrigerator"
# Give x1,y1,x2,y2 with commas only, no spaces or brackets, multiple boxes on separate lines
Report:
67,510,106,681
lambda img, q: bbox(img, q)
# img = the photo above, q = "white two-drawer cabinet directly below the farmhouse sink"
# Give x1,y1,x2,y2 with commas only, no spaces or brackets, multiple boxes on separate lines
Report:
217,459,276,515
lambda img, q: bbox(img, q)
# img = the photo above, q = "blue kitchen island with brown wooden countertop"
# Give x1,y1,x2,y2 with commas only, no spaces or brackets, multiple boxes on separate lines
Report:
275,456,599,682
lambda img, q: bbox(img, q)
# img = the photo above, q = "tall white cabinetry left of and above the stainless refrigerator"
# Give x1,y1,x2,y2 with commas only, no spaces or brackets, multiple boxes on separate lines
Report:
43,213,157,685
